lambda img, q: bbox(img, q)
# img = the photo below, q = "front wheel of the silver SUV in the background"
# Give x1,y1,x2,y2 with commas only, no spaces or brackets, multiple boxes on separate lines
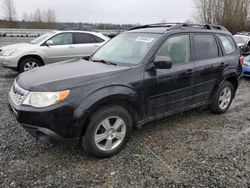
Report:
18,57,42,73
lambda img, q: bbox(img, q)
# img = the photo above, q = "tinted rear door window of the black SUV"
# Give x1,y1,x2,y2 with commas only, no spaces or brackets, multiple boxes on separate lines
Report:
194,34,219,61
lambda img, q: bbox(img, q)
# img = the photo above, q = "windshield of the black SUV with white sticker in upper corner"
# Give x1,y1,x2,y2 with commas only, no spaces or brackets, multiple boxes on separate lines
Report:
91,33,161,65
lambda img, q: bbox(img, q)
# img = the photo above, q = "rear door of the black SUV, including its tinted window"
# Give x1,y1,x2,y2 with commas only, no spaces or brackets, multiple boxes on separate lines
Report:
192,33,227,103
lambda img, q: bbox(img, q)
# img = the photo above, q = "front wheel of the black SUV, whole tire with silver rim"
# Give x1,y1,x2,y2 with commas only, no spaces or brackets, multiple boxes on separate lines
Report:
81,105,132,158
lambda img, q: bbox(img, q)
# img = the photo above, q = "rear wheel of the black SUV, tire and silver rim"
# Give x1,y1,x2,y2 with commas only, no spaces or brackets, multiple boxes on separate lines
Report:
209,81,235,114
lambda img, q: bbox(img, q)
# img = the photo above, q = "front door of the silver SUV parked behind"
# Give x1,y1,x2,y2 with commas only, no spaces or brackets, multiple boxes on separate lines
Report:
42,33,74,63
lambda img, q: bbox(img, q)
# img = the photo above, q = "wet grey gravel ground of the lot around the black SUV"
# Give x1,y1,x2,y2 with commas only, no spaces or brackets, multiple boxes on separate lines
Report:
0,37,250,187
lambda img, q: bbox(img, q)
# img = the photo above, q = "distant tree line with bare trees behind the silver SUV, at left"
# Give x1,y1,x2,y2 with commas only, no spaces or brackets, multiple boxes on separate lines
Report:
0,0,137,30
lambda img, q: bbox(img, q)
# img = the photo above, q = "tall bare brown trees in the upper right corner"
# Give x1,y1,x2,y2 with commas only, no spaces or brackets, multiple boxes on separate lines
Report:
194,0,250,33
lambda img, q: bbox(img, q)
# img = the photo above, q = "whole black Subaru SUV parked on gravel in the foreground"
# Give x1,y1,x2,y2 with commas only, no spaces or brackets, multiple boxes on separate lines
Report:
9,23,242,157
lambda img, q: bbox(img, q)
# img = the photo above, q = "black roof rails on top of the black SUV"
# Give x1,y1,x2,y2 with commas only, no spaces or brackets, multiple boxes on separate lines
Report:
130,23,228,31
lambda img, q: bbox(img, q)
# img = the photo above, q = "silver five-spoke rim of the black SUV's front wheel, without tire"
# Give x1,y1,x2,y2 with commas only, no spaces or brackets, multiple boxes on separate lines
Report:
94,116,126,151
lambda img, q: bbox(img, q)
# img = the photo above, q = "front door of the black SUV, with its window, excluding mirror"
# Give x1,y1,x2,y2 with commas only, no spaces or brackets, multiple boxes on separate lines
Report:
144,34,195,116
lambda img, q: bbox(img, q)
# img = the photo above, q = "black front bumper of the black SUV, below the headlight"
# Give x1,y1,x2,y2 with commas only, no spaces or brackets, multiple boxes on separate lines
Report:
8,95,83,145
